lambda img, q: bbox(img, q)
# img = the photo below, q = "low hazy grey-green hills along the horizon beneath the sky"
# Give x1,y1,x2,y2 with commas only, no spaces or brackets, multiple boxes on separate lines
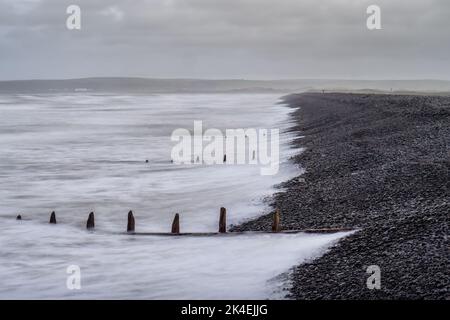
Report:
0,77,450,94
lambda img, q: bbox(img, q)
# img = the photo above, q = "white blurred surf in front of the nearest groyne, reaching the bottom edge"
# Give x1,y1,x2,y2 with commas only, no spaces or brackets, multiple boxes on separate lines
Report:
0,220,349,299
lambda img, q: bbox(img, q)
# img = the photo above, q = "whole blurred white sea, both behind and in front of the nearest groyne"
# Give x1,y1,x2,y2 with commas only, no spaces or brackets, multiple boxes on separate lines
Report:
0,94,344,299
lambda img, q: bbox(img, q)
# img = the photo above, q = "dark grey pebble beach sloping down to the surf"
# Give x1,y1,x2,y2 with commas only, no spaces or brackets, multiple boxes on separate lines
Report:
234,93,450,299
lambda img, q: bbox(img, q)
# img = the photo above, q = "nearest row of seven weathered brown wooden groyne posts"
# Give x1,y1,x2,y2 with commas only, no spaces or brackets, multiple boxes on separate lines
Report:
17,207,281,235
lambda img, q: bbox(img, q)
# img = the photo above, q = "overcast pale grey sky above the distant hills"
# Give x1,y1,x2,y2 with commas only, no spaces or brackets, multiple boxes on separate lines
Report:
0,0,450,80
